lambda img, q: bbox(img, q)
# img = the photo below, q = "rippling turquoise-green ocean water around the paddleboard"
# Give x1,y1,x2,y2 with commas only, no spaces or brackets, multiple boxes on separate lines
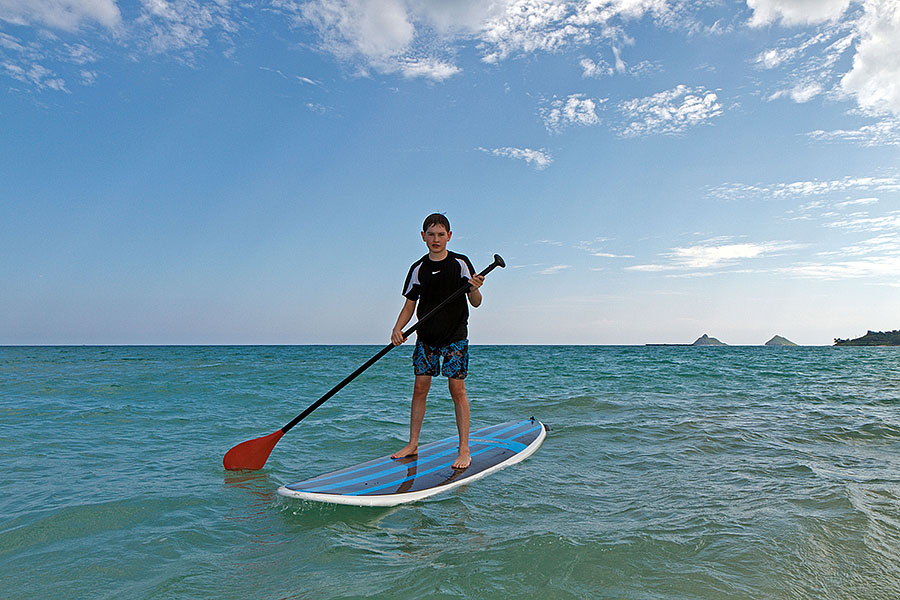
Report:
0,346,900,600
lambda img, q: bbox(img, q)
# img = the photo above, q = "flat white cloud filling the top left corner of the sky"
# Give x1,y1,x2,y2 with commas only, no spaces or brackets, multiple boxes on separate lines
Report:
0,0,122,31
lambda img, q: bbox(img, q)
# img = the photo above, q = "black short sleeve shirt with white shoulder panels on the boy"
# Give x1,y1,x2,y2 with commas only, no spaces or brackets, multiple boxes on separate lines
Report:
403,250,475,346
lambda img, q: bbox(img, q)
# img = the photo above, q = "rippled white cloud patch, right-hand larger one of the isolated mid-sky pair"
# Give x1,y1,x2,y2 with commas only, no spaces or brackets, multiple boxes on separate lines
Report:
619,85,722,137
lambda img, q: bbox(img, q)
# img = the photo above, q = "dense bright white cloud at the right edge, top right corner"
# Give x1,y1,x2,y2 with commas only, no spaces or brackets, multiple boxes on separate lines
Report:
841,0,900,116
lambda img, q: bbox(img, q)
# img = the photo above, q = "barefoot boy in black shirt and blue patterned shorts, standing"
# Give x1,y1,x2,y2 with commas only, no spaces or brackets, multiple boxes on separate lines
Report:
391,213,484,469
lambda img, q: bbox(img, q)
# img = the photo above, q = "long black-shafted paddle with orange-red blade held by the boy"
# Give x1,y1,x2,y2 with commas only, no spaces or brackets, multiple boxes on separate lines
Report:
222,254,506,471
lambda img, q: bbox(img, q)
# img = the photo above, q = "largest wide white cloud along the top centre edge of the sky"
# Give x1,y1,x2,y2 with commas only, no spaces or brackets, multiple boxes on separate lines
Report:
292,0,676,78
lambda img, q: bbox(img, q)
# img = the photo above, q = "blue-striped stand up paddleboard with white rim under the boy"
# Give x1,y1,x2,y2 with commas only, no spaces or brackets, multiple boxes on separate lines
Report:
278,417,547,506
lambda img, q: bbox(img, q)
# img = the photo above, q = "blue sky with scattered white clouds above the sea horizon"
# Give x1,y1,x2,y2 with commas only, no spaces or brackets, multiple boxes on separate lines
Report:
0,0,900,345
